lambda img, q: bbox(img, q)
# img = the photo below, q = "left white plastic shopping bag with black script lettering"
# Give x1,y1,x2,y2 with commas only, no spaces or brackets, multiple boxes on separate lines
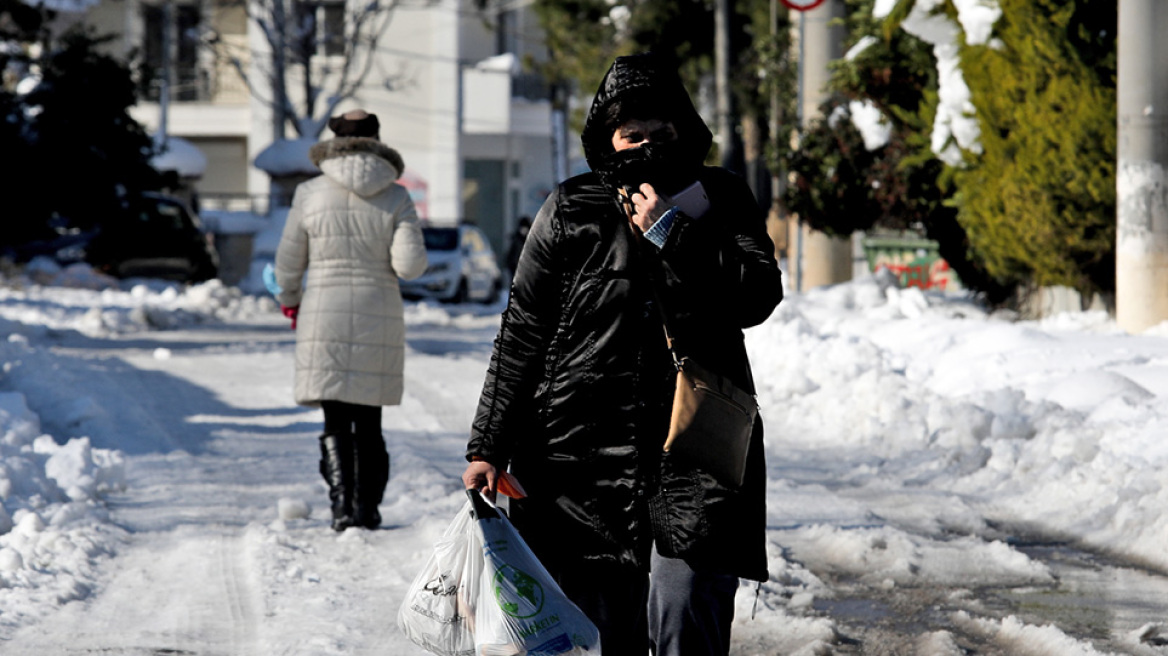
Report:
397,501,485,656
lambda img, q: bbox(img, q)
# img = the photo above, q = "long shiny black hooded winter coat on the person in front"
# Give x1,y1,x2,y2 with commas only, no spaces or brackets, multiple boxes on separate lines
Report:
467,55,783,580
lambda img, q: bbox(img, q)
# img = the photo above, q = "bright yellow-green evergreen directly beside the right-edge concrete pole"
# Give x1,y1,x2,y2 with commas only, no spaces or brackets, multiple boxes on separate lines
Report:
955,0,1117,293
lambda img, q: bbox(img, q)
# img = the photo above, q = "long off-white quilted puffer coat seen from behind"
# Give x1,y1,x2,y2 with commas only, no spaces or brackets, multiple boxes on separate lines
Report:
276,138,426,406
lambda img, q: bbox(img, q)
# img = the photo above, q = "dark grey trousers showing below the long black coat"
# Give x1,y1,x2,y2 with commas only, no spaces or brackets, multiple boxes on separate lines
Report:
649,541,738,656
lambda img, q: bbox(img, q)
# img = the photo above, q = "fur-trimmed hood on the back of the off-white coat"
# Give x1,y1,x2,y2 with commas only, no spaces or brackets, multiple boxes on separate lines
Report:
308,137,405,196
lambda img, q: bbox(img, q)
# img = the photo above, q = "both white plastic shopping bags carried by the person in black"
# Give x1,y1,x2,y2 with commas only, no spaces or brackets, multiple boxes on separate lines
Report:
397,490,600,656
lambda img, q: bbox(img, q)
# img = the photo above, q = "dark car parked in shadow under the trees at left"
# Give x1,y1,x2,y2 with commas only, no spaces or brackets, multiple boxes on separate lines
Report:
5,193,218,282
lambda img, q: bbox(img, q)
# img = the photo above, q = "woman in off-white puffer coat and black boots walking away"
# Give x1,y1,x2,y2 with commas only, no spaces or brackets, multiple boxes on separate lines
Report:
276,110,426,531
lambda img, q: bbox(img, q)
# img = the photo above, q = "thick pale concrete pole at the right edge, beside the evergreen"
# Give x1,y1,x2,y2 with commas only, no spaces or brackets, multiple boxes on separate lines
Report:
1115,0,1168,333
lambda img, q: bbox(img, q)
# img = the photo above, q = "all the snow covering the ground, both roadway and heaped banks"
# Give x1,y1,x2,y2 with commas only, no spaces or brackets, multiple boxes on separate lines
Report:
0,239,1168,656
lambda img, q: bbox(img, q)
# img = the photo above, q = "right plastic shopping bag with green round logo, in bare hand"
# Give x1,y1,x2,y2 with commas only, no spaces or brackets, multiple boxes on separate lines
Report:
467,490,600,656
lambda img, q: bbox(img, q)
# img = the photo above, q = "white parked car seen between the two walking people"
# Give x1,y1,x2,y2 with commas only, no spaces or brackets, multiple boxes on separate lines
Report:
402,224,503,302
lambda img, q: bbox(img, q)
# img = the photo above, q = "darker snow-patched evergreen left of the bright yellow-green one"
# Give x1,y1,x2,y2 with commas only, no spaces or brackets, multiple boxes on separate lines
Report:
780,0,1010,303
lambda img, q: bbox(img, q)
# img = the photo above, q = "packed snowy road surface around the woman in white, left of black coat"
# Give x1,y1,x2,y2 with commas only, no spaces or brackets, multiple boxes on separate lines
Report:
0,303,494,655
